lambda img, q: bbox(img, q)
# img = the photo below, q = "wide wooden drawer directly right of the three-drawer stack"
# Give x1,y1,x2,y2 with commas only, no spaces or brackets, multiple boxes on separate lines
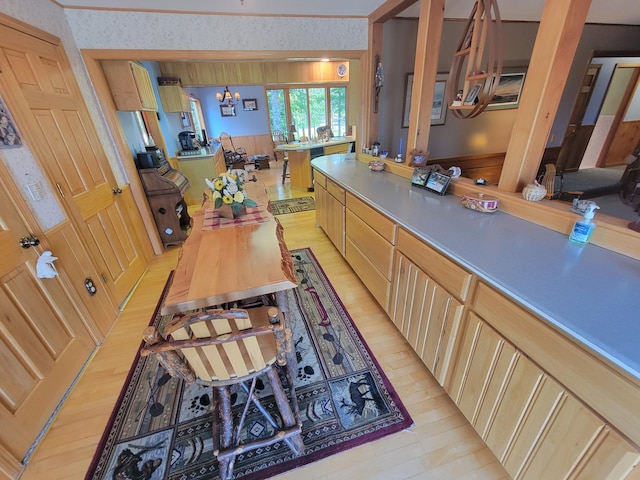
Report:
396,229,472,300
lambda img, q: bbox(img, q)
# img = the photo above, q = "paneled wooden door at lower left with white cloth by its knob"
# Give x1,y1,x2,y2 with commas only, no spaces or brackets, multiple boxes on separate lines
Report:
0,175,95,468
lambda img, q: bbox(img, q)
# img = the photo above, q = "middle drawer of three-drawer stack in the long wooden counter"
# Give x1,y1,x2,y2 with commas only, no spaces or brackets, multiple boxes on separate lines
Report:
345,209,393,280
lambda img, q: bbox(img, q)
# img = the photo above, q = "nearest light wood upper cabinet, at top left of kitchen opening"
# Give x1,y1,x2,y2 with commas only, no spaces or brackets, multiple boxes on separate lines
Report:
102,60,158,112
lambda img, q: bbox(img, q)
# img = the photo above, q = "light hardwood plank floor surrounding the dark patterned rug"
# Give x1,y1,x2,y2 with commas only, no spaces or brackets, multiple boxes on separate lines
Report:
22,161,510,480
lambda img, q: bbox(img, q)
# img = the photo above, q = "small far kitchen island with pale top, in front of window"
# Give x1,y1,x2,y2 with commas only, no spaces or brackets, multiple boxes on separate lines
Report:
276,137,355,191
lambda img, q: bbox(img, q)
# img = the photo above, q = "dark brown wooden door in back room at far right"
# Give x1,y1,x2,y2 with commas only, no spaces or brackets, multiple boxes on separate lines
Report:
556,64,602,172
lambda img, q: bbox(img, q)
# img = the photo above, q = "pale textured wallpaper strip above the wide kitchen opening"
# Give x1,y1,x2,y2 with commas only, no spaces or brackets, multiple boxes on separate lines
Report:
65,10,368,51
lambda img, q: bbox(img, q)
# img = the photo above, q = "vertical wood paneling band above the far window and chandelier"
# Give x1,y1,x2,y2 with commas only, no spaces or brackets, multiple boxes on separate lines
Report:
159,61,349,87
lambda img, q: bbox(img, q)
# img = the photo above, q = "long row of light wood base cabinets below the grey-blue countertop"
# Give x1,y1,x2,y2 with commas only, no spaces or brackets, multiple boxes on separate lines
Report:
315,173,640,480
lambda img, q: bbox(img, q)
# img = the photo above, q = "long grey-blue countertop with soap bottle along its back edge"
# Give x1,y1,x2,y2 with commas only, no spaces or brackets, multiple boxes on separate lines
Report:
311,154,640,379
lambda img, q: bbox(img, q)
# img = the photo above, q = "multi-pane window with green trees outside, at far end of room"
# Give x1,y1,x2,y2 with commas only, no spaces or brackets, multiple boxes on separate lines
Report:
267,86,347,140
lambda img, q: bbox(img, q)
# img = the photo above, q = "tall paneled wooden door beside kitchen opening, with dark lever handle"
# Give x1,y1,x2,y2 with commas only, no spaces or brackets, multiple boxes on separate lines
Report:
0,25,146,305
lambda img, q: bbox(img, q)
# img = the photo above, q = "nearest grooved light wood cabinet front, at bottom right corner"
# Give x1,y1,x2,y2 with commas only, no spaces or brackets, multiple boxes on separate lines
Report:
446,312,640,480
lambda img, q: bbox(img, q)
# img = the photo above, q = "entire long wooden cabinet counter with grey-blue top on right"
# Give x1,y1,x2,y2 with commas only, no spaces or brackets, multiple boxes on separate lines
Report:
312,155,640,479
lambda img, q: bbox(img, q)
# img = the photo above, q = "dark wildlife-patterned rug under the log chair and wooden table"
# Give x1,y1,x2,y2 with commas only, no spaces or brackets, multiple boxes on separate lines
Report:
86,248,412,480
